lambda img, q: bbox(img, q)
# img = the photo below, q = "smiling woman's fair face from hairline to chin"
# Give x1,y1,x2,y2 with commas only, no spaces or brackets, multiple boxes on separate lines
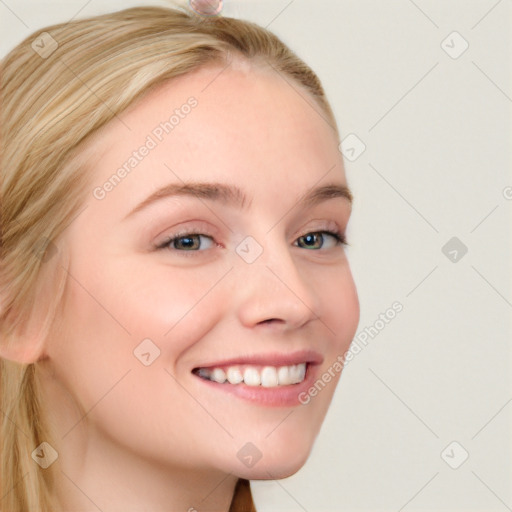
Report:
42,60,359,479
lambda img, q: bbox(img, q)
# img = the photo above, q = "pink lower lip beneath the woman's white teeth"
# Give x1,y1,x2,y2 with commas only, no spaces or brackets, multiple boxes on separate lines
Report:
195,363,319,407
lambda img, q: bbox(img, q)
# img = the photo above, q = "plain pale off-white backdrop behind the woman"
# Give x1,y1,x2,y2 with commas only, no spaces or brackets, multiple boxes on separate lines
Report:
0,0,512,512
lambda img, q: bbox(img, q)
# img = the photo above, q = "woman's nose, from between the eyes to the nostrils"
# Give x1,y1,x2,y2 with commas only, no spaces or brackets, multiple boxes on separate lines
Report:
233,240,320,330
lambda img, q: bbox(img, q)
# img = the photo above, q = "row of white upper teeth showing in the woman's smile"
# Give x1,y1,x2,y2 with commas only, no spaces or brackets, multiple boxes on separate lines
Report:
197,363,306,388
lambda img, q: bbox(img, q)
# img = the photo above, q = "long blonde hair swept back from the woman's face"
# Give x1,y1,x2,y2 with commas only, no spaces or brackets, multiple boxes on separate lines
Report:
0,7,338,512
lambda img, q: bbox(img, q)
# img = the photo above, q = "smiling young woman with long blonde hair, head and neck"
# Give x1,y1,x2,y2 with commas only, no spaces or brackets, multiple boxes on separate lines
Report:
0,7,359,512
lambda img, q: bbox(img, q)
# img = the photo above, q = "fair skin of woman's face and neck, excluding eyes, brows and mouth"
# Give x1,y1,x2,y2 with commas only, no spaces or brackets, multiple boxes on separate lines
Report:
33,58,359,512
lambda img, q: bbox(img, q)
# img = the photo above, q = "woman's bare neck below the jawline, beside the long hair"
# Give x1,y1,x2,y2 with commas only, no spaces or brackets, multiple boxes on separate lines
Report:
56,428,238,512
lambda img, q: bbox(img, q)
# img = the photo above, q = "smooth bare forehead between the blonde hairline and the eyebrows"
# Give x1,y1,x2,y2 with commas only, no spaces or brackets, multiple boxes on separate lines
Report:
84,60,345,216
